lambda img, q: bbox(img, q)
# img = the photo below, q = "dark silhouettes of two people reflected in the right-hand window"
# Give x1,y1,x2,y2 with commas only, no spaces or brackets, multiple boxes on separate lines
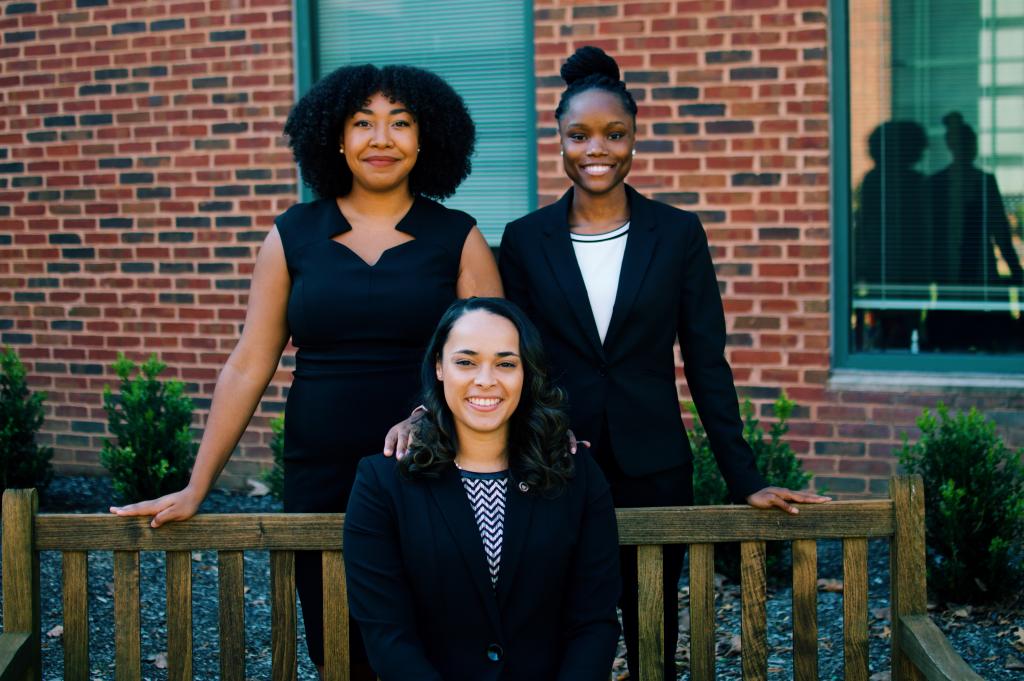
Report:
853,112,1024,353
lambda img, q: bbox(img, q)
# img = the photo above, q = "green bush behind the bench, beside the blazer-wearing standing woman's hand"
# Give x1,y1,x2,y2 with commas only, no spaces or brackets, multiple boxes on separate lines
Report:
687,392,811,579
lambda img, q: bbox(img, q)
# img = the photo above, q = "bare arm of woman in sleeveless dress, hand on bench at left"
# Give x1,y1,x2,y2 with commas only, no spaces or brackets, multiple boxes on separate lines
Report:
111,227,291,527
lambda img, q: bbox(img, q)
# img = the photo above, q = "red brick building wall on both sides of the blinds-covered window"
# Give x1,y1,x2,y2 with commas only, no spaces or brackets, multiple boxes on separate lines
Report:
0,0,1024,496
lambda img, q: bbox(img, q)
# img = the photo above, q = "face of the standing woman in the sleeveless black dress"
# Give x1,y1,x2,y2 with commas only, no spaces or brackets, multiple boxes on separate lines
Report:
341,92,420,191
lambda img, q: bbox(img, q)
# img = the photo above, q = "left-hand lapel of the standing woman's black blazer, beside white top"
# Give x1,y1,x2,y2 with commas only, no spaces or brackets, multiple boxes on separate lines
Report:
543,184,604,357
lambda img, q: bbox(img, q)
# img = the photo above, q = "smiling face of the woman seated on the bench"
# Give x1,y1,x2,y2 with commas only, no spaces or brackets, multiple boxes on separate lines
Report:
435,309,524,441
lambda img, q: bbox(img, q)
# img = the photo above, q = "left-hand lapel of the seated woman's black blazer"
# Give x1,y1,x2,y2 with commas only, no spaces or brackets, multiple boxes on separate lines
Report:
429,466,504,632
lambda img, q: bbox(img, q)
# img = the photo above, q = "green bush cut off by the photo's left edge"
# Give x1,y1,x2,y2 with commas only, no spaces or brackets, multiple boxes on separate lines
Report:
0,348,53,494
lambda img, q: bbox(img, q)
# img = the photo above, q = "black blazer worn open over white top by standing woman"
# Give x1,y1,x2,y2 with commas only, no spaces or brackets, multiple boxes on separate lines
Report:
499,185,766,502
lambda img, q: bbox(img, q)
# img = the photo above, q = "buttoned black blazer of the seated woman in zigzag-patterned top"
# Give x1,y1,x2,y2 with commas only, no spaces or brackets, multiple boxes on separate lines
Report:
344,456,620,681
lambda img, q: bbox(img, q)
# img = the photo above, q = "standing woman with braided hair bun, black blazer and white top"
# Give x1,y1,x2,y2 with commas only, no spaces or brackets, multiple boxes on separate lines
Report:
499,47,826,679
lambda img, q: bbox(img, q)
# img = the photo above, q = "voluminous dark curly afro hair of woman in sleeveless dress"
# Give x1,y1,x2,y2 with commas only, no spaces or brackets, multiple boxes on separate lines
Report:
285,63,476,199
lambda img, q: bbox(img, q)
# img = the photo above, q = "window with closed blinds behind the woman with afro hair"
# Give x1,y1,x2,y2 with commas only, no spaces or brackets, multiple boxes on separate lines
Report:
297,0,537,245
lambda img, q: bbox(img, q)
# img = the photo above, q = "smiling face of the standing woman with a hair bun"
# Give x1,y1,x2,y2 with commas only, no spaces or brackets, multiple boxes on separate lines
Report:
558,88,636,194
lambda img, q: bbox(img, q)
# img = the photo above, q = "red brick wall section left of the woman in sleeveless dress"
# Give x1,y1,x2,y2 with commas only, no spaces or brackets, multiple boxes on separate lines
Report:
0,0,296,489
